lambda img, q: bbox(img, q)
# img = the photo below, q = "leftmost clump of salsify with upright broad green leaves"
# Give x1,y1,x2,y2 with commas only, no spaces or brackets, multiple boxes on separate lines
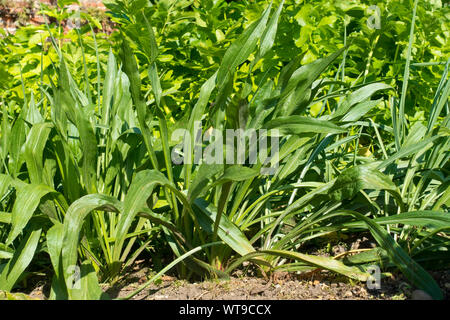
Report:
1,47,160,298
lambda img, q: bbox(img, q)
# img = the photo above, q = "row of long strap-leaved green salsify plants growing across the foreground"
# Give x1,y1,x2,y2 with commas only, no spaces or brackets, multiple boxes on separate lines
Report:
0,1,450,299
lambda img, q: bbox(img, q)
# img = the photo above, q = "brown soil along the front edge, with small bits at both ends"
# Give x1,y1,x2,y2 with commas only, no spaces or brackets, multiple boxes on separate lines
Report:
29,266,450,300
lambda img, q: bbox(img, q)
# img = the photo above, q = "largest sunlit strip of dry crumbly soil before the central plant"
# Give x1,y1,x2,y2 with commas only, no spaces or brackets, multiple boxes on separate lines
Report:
107,277,398,300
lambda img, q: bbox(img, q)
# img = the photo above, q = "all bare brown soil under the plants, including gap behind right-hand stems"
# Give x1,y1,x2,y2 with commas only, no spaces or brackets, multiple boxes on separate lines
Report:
20,234,450,300
